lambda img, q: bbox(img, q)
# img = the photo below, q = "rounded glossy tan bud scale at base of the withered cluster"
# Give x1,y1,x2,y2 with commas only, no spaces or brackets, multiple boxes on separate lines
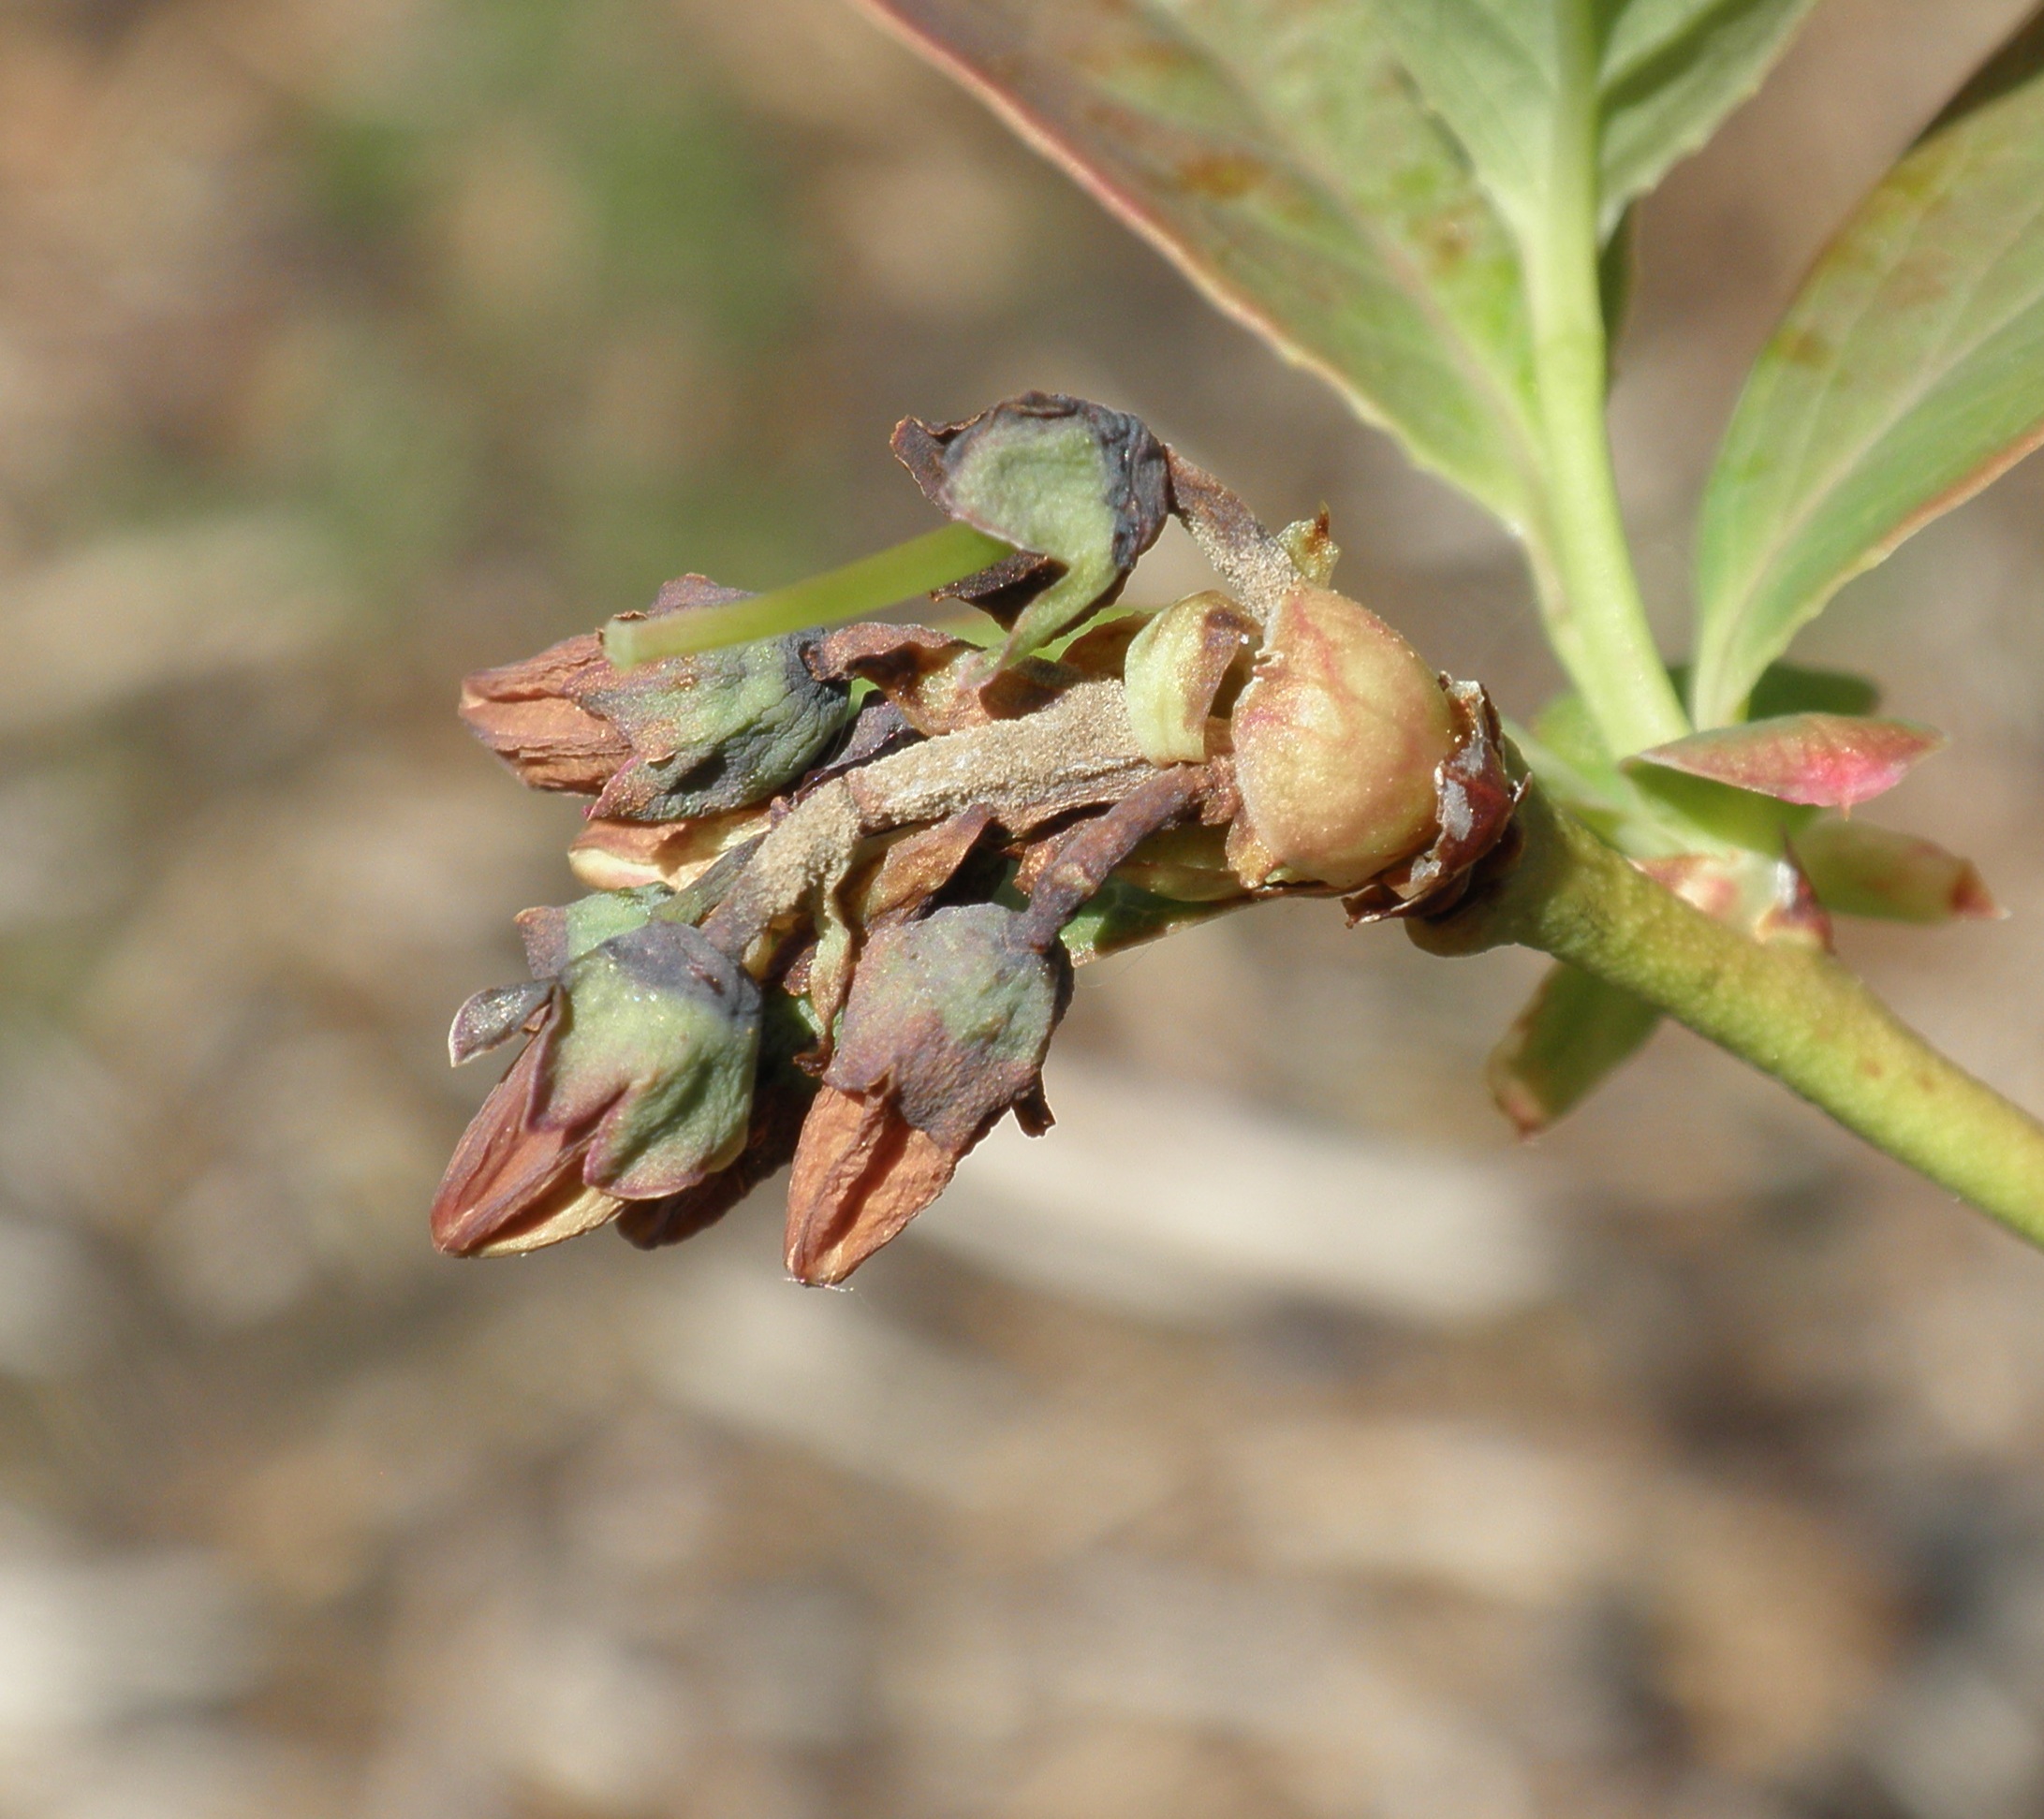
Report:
1230,587,1457,889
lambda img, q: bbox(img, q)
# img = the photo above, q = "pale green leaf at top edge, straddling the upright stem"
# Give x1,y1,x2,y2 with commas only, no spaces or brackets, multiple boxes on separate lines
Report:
1382,0,1811,245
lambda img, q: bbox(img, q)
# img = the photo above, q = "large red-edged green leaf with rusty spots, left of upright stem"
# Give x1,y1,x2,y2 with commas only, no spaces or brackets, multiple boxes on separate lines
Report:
867,0,1539,539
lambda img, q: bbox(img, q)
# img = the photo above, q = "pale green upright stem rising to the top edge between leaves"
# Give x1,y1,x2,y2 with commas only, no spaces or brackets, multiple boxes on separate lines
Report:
1522,0,1688,758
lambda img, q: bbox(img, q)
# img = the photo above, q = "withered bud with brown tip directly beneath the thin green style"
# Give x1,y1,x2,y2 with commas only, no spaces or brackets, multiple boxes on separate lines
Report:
462,577,852,822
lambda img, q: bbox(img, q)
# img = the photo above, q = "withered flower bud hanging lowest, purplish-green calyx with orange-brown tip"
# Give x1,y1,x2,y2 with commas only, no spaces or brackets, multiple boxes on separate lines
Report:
787,903,1071,1282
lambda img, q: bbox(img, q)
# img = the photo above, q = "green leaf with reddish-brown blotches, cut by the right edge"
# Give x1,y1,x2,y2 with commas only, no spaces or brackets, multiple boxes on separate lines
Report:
1695,22,2044,726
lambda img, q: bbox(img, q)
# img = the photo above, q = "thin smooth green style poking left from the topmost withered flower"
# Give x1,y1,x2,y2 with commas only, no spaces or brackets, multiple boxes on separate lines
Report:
603,523,1012,670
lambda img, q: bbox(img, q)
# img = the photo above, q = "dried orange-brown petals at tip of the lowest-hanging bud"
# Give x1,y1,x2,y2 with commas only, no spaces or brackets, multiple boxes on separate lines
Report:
787,1085,959,1285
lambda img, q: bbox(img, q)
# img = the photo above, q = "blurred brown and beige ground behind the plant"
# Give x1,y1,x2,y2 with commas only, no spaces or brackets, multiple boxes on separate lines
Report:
0,0,2044,1819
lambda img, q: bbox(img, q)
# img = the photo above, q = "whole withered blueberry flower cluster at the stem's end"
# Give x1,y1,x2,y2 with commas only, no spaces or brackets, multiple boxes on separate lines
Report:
432,392,1517,1284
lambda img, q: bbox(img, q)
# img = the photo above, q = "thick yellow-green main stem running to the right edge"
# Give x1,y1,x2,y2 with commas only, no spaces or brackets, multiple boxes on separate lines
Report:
1408,785,2044,1245
